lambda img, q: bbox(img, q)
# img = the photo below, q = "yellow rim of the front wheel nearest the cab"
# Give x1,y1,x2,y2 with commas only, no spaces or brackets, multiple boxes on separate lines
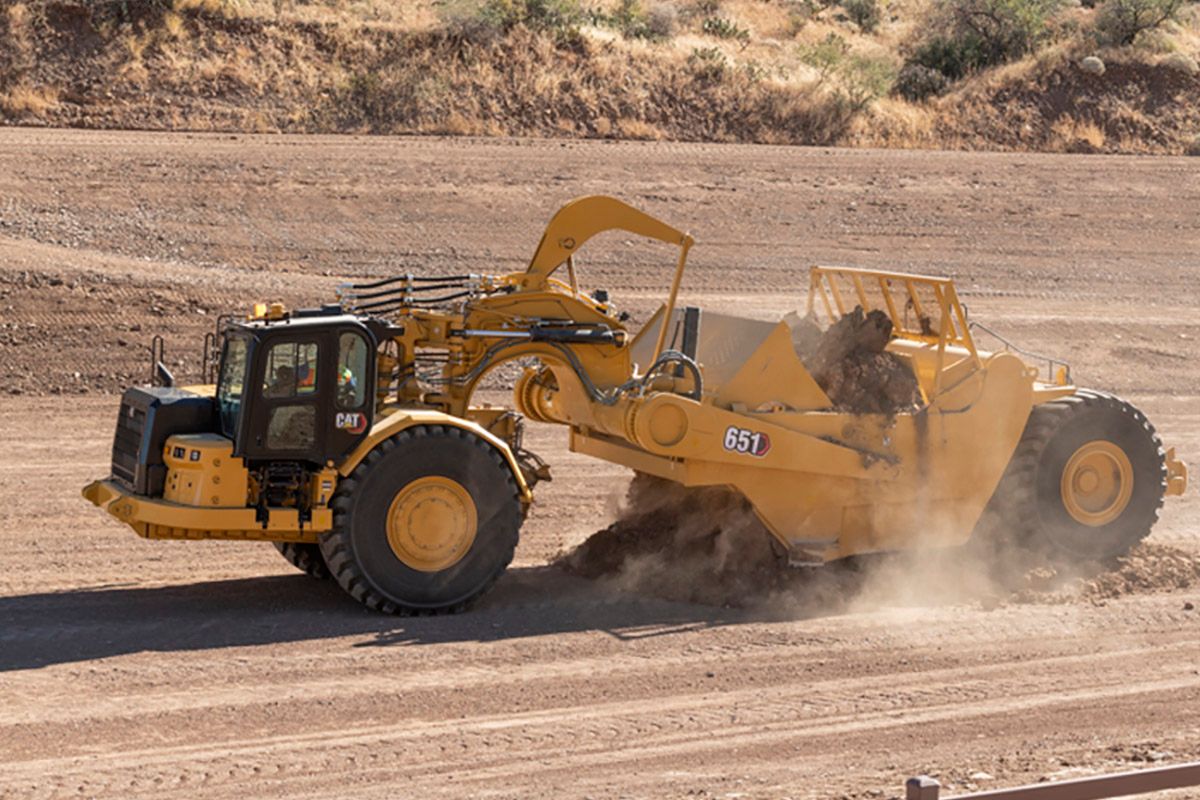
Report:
388,475,478,572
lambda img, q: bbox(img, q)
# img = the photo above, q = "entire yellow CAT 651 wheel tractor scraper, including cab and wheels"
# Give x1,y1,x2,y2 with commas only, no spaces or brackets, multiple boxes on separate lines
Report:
84,197,1187,613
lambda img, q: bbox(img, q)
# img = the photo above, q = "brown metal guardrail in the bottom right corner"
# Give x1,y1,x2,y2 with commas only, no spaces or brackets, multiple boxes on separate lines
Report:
905,762,1200,800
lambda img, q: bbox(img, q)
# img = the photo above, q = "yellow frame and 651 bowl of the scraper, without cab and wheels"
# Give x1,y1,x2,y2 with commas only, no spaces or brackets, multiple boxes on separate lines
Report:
85,197,1186,560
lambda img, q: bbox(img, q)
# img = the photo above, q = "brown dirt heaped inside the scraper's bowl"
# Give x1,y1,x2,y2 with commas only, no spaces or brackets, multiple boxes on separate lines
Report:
788,306,920,414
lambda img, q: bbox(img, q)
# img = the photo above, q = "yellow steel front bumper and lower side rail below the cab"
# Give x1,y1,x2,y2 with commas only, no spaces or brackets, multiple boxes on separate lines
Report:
83,481,334,542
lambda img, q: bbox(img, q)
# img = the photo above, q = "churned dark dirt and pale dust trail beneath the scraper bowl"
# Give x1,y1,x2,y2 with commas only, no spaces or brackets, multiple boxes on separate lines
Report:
558,474,1200,616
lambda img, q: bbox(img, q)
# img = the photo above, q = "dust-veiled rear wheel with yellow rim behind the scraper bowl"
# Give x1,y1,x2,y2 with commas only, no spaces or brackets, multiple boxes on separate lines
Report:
989,390,1166,561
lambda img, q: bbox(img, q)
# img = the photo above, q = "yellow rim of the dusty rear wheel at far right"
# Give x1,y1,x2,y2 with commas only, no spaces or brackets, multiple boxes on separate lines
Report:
1062,439,1133,528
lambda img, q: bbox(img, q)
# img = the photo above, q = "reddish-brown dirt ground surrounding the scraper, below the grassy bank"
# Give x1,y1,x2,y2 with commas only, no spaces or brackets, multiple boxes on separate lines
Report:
0,130,1200,799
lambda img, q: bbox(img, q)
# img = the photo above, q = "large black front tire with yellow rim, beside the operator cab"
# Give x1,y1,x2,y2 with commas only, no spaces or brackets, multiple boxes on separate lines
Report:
320,426,523,614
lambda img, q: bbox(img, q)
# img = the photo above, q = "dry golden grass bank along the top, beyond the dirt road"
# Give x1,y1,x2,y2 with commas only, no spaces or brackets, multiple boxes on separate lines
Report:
0,0,1200,152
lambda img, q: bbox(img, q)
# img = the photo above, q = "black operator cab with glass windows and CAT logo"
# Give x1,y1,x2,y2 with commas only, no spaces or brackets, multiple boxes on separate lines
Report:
215,311,378,465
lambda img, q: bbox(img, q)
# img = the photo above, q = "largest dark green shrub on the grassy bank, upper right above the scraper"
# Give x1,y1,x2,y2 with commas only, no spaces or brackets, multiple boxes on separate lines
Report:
908,0,1062,80
